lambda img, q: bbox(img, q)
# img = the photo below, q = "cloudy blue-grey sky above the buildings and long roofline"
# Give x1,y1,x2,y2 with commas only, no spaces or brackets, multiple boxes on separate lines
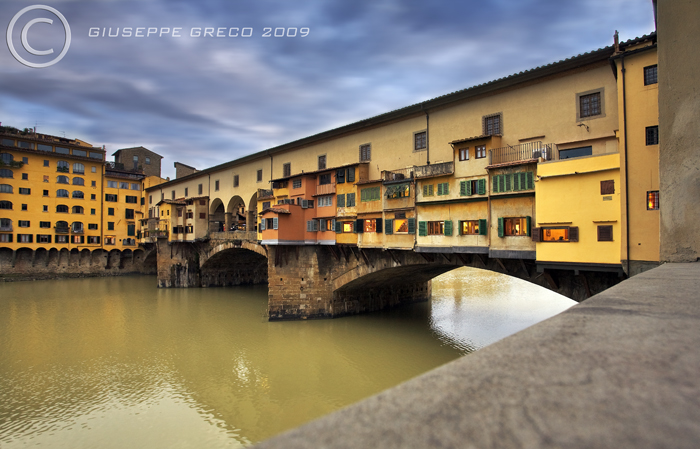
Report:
0,0,654,178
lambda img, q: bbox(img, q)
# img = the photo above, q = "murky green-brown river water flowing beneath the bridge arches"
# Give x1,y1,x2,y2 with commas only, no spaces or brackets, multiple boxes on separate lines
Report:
0,268,574,449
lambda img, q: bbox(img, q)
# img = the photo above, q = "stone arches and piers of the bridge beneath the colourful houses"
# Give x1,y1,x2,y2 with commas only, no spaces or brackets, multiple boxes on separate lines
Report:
158,231,622,320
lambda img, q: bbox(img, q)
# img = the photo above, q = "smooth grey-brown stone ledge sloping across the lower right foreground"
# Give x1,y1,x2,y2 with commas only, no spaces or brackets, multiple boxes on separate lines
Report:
256,263,700,449
